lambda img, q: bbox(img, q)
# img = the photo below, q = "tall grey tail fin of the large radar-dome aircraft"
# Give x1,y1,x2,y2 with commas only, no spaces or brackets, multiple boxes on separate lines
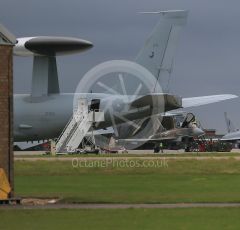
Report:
135,10,188,91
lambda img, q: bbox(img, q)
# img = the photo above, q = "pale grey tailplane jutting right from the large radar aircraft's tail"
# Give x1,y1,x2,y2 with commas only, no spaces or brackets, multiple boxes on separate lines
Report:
182,94,238,108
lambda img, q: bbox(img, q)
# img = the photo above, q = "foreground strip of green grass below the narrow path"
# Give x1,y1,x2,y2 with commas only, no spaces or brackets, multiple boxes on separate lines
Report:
0,208,240,230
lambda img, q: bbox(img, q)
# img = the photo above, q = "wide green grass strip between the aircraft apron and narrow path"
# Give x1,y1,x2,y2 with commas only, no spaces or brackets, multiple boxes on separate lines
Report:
15,159,240,203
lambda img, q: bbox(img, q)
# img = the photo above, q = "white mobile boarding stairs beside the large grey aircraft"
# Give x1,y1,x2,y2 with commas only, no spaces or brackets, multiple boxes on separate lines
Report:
56,98,104,153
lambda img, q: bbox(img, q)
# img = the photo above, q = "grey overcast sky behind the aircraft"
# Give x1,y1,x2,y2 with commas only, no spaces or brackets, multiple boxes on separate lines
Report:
0,0,240,133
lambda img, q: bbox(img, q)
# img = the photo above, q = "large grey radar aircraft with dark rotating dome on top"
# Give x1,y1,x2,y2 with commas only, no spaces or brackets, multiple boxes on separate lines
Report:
9,10,236,142
